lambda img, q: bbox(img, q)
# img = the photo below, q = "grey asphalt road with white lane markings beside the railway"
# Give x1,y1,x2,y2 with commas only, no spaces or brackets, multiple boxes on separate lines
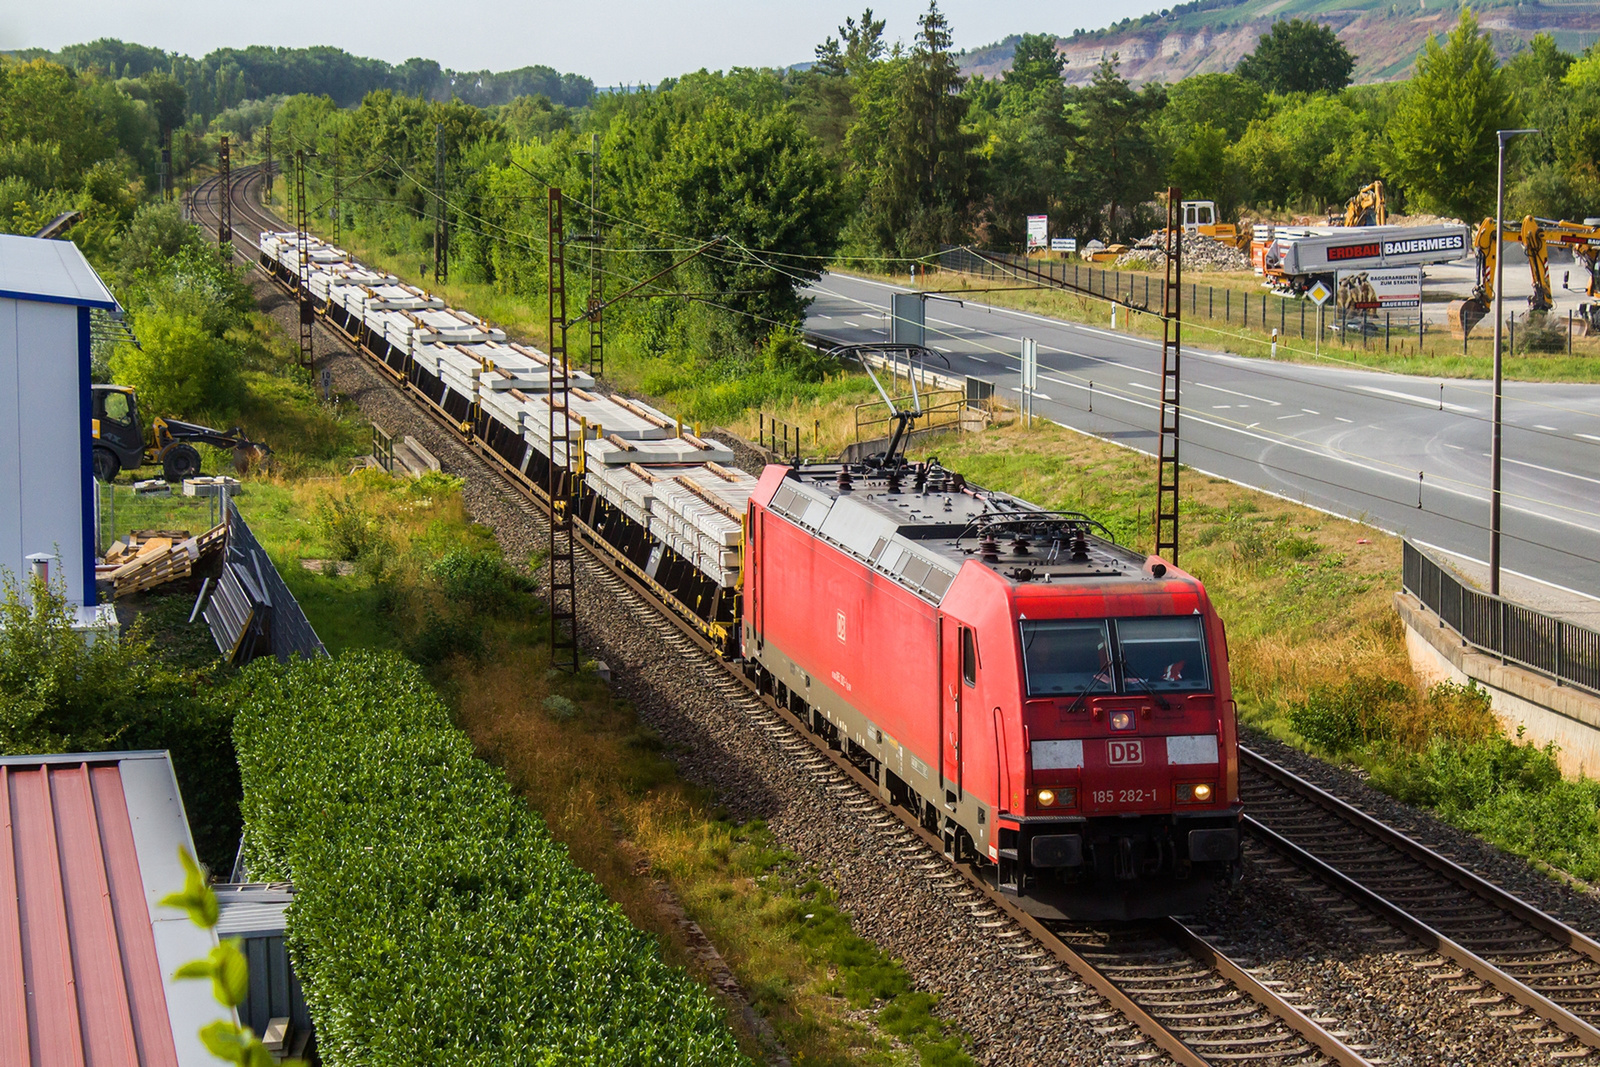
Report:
806,274,1600,598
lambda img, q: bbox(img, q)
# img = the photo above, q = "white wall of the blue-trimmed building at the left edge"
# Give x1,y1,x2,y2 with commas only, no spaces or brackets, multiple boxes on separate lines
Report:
0,299,94,603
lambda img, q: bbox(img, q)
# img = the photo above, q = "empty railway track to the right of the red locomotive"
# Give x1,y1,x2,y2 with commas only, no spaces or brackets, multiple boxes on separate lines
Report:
1238,745,1600,1059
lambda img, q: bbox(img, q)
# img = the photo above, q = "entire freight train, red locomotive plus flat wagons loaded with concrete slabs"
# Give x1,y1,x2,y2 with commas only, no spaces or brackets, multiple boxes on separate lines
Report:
259,232,1242,918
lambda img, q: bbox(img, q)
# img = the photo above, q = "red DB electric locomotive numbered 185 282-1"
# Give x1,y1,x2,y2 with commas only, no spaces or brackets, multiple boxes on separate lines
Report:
741,462,1240,918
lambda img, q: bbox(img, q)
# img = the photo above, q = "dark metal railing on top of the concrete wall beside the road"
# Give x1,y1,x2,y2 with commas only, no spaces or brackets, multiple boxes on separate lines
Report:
1400,541,1600,694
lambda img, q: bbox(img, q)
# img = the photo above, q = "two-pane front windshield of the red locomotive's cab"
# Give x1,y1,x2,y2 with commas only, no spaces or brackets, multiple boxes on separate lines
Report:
1021,616,1211,696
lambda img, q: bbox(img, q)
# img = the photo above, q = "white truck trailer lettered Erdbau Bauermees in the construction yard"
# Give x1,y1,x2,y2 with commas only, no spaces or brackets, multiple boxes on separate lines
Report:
1250,224,1472,296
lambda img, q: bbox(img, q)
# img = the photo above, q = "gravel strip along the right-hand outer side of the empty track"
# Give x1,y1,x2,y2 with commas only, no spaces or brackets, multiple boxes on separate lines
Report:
1242,733,1600,937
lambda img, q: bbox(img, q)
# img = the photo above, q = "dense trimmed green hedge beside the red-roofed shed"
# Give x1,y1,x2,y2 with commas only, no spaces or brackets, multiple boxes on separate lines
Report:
234,653,749,1067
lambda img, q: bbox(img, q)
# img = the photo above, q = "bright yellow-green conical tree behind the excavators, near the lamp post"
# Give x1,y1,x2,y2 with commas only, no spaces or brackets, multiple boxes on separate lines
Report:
1390,8,1512,219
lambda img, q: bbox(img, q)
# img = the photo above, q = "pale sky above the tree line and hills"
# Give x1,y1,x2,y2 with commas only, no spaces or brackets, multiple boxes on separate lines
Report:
0,0,1160,86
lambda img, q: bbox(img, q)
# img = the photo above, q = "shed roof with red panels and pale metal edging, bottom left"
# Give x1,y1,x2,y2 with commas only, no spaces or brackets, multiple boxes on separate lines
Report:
0,752,234,1067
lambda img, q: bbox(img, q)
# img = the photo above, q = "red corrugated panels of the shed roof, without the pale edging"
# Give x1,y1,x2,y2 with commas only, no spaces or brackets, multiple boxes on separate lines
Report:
0,757,178,1067
